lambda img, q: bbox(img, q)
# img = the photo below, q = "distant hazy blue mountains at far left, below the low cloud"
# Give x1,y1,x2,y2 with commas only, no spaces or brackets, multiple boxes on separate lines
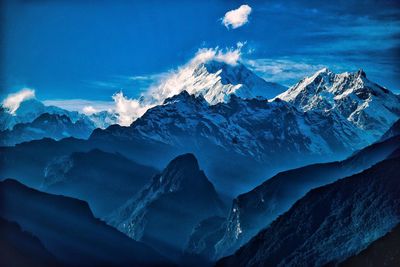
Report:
0,99,117,146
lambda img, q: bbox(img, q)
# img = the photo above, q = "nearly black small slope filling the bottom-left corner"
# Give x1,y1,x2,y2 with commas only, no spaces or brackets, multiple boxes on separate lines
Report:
0,217,62,267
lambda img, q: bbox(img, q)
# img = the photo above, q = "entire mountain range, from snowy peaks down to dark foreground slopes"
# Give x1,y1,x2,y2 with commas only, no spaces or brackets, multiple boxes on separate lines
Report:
0,61,400,266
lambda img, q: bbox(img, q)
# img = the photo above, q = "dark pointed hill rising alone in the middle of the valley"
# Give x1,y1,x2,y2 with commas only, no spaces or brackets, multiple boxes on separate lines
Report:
108,154,227,258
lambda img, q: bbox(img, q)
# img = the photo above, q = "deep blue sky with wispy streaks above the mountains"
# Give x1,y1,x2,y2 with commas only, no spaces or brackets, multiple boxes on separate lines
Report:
0,0,400,101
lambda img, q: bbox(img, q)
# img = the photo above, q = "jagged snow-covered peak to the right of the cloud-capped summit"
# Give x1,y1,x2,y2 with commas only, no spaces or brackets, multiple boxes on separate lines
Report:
277,68,400,141
